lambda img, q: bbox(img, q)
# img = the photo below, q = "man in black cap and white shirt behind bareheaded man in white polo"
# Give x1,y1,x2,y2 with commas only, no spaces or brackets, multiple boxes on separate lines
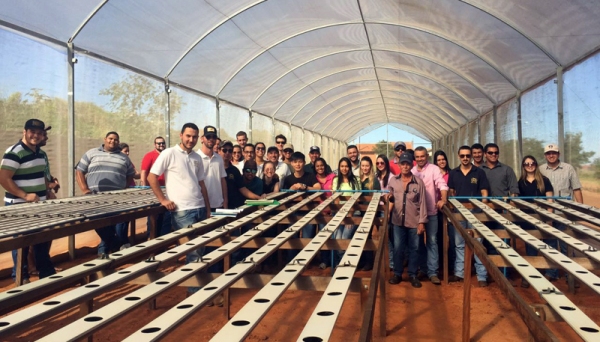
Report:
198,126,228,211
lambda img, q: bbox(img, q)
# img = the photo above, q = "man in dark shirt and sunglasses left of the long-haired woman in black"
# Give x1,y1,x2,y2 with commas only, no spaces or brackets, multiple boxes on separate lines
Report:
481,143,519,197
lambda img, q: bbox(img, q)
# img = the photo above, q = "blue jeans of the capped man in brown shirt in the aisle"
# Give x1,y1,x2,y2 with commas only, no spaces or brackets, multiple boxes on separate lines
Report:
392,225,419,278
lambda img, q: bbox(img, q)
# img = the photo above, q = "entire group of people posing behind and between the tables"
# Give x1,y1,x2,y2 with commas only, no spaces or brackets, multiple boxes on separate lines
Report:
0,119,583,288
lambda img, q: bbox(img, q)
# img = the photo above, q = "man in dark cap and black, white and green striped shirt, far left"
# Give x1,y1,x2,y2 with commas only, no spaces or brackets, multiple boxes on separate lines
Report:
0,119,56,285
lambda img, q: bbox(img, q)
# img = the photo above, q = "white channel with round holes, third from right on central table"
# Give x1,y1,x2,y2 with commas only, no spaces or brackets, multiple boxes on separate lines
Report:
125,193,341,342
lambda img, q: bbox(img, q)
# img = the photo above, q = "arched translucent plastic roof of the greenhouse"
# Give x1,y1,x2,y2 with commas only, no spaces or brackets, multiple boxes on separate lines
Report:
0,0,600,141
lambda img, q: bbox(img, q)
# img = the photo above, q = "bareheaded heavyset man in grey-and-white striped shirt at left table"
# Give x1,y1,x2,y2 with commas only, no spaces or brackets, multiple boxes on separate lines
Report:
75,132,135,255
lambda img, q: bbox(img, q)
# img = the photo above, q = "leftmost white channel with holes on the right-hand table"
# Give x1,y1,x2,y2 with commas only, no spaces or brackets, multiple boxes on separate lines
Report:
450,200,600,341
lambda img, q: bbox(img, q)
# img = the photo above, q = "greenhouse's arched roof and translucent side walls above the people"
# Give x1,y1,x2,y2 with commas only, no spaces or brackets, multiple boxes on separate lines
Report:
0,0,600,339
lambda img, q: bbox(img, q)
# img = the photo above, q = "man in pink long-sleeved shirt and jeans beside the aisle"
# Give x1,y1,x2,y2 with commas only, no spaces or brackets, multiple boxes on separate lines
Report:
411,146,448,285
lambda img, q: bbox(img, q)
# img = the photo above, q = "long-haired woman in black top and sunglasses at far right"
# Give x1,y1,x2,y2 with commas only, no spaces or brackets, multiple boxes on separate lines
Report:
519,156,558,288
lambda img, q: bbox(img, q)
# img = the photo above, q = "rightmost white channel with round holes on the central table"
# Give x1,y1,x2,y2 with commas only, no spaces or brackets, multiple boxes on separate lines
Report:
298,194,381,342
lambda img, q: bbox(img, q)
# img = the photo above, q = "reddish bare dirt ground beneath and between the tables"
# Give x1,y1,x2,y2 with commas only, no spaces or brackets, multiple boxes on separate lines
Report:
0,192,600,341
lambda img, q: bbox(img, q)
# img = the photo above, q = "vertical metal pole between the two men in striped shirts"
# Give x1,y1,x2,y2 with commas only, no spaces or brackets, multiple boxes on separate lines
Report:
67,43,77,260
